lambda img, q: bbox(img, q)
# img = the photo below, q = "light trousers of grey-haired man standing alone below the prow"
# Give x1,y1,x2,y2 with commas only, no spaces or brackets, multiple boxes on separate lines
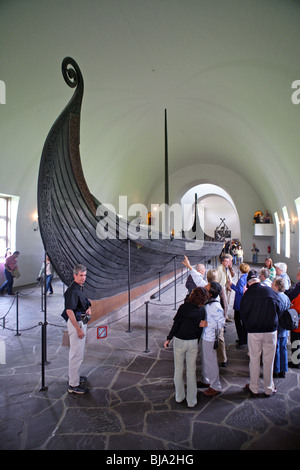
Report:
67,320,87,387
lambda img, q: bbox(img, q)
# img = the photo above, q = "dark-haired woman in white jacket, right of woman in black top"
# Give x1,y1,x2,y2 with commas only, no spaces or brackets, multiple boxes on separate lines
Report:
201,282,225,397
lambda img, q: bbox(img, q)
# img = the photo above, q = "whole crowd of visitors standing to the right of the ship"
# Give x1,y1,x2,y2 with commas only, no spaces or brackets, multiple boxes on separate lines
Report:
164,254,300,407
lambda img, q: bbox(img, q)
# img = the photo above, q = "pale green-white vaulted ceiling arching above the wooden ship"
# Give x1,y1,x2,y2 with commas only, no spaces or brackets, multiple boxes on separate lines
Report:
0,0,300,217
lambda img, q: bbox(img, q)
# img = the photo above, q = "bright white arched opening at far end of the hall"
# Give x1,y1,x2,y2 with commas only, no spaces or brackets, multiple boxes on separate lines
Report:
180,183,241,240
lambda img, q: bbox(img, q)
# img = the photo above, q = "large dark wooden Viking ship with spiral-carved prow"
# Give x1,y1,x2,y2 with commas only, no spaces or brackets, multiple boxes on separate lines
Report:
37,57,221,300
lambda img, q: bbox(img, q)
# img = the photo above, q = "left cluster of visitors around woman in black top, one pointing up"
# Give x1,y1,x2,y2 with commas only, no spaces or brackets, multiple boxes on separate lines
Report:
164,255,232,407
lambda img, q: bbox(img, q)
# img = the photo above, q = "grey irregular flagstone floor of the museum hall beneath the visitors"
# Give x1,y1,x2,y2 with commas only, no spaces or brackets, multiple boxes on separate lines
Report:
0,272,300,451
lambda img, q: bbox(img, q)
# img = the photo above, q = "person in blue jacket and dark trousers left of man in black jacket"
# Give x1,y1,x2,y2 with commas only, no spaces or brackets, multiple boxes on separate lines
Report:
228,263,250,348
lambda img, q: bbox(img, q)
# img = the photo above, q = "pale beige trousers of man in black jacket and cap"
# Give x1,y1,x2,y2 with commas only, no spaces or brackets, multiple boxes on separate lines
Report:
248,331,277,395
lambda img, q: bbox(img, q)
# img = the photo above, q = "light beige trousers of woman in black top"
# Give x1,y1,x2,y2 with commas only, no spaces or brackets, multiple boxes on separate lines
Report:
173,337,198,407
